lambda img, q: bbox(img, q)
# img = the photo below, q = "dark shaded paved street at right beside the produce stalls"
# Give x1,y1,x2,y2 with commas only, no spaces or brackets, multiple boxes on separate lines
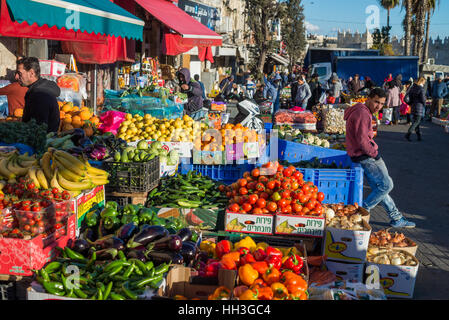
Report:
365,122,449,299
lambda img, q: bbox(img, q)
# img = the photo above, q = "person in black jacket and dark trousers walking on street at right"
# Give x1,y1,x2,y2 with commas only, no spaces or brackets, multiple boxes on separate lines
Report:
405,77,426,141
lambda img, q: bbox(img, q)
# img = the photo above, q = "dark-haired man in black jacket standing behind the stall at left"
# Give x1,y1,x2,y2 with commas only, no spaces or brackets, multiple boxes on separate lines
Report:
17,57,61,132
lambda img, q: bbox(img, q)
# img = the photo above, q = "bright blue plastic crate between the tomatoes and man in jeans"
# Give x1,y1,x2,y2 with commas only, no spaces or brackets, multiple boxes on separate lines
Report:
298,166,363,204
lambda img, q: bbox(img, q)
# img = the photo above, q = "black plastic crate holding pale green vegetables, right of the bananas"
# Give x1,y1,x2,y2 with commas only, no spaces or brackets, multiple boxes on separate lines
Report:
103,157,160,192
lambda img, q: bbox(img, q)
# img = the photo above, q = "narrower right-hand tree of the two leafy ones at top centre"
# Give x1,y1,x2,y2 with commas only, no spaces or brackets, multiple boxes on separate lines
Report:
281,0,307,70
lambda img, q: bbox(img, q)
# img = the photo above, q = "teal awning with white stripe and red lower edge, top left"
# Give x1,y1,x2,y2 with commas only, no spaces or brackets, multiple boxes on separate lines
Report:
0,0,145,42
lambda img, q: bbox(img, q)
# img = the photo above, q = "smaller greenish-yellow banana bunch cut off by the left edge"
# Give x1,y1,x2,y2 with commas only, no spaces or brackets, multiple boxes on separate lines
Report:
0,151,37,183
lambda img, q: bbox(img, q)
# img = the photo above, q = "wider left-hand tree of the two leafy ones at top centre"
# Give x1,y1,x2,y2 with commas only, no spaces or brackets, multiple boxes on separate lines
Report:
245,0,285,80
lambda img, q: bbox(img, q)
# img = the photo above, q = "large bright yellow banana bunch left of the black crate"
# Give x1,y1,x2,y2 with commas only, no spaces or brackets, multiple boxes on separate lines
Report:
36,148,109,197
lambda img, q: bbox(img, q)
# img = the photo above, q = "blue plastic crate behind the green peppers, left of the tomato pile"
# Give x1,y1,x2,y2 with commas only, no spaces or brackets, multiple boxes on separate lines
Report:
179,163,257,184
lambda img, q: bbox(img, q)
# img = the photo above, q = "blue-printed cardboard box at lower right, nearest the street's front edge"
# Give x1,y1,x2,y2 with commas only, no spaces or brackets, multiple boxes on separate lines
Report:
366,254,419,298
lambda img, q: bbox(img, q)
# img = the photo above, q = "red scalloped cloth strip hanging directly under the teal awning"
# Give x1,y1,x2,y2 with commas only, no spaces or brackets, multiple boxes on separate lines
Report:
0,0,107,44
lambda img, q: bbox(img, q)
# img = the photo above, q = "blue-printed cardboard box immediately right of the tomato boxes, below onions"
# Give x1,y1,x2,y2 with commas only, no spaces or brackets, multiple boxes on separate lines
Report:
323,220,372,263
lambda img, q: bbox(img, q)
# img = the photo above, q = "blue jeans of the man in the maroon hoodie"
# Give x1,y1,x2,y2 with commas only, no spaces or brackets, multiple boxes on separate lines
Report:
360,158,402,220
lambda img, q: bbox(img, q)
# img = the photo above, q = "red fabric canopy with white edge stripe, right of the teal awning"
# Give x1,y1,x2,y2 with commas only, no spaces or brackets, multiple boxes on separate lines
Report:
136,0,222,58
